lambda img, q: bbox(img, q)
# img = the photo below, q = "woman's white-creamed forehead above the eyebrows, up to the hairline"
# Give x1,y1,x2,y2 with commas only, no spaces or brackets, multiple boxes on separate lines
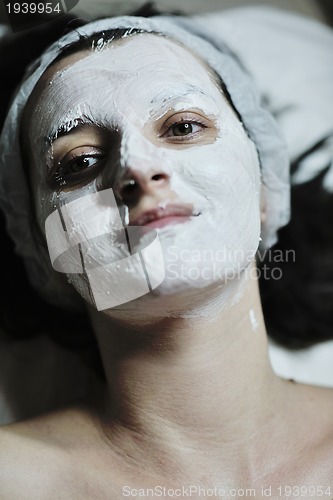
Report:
31,34,221,116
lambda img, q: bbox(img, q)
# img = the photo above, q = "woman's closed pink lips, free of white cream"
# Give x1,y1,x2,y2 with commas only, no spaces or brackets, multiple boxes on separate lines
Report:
129,204,194,228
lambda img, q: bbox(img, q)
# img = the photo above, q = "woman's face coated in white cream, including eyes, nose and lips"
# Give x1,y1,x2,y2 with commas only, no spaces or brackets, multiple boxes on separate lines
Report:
25,34,260,311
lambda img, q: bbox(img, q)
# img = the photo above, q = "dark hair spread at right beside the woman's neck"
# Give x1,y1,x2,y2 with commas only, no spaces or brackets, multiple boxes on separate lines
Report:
259,163,333,349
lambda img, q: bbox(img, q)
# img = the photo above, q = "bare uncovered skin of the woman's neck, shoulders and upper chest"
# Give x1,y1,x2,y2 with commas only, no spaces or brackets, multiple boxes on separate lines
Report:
0,36,333,499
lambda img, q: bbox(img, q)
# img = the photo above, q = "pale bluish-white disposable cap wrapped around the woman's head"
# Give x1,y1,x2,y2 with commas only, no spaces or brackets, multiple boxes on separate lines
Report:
0,16,290,307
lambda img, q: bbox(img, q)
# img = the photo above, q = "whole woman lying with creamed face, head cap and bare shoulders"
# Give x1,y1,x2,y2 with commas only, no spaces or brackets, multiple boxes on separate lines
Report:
0,9,333,499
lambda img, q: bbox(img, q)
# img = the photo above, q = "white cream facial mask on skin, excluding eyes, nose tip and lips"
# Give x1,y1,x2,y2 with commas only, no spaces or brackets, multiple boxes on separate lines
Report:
30,35,260,317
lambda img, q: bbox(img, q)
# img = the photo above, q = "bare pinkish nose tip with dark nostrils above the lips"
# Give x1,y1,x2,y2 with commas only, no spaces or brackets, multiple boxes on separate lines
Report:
116,167,170,207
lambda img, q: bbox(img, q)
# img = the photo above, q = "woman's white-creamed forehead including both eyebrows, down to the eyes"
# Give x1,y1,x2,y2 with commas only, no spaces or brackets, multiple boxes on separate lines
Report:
23,34,229,148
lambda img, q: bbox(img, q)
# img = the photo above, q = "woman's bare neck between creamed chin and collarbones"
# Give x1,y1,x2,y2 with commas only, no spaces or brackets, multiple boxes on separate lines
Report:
87,262,280,480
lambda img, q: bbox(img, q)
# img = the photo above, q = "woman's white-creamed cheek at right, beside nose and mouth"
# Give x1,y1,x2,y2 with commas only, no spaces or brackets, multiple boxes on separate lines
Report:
168,126,260,222
